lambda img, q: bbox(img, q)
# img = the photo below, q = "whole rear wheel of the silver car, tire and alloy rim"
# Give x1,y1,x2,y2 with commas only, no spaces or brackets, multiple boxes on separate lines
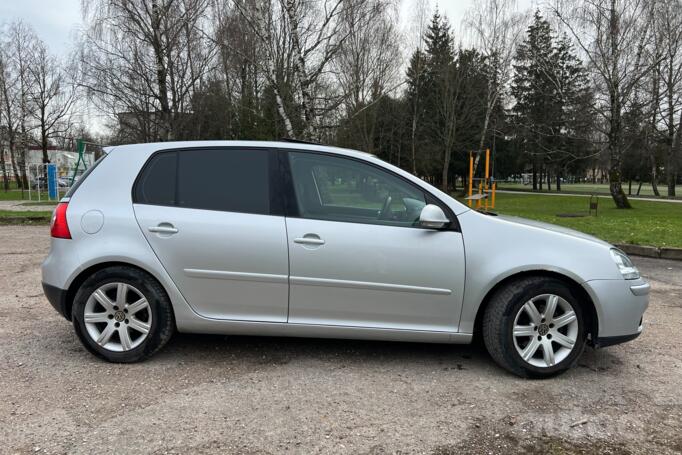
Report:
72,266,174,363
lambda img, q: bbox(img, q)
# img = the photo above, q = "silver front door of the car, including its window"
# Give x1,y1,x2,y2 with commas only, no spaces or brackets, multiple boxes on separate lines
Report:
286,152,464,331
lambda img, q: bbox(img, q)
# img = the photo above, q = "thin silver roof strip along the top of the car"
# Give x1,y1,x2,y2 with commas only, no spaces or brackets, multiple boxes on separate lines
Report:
107,141,374,158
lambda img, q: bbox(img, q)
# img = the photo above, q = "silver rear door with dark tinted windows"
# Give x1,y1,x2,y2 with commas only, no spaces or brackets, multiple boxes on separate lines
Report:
133,148,289,322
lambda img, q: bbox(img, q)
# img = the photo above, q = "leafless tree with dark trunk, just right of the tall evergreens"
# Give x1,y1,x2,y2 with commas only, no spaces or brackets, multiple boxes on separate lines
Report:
553,0,656,208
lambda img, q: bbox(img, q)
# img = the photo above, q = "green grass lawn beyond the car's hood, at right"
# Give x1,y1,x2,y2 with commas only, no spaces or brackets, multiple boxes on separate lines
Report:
470,193,682,247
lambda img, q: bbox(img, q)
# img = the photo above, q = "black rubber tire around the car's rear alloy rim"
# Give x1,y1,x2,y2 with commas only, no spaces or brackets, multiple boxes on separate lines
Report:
71,266,175,363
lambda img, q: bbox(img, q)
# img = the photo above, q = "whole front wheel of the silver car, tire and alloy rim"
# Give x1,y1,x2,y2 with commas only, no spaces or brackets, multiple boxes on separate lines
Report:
483,277,587,378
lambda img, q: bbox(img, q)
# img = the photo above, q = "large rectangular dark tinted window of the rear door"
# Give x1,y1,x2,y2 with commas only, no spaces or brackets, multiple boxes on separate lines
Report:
176,149,270,215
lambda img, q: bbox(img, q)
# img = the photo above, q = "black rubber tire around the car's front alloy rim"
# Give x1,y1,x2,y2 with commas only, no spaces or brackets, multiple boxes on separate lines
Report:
483,277,587,378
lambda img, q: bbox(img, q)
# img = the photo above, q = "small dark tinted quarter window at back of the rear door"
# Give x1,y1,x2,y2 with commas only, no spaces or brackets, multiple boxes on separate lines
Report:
135,152,177,205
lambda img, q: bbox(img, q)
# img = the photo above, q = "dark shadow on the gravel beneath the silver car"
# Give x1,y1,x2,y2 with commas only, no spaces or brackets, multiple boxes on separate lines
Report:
146,333,623,377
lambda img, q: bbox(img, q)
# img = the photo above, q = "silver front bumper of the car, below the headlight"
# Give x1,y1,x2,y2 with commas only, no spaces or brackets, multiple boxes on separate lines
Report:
585,278,651,347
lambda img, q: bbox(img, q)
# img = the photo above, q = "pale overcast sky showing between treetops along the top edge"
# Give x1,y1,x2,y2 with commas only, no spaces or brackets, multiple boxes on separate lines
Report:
0,0,539,56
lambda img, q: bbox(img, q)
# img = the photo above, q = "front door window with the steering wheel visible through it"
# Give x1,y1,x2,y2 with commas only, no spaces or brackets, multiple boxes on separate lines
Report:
289,152,426,226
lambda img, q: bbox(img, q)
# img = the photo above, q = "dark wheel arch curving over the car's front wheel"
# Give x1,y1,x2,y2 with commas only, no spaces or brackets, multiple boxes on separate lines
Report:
474,270,599,341
